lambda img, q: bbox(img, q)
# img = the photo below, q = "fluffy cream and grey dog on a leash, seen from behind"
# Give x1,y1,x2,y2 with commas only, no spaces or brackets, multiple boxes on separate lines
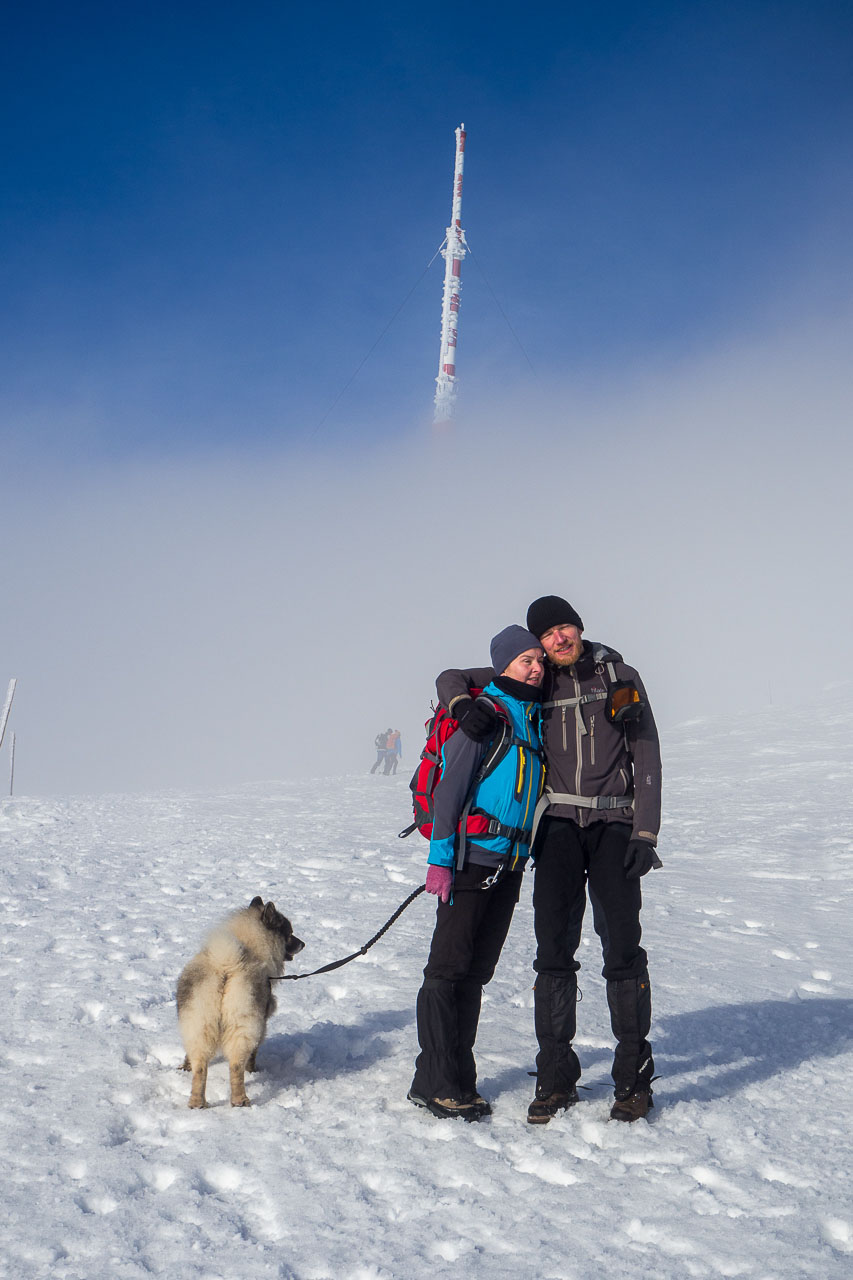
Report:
178,897,305,1107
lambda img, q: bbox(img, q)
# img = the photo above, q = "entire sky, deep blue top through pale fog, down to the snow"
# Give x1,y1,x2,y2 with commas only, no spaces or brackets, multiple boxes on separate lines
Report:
0,0,853,798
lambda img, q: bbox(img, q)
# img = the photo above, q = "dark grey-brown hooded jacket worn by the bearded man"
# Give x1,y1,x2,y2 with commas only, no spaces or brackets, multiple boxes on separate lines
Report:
435,640,661,842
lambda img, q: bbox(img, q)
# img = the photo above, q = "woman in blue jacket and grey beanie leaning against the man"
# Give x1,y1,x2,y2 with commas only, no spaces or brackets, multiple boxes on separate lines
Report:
409,626,544,1120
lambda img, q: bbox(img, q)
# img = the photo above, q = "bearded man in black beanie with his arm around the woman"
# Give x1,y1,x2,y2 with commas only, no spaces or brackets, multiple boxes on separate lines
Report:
435,595,661,1124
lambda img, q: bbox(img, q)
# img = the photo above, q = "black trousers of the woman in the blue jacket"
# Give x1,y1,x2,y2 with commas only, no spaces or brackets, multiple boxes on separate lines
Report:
411,864,523,1101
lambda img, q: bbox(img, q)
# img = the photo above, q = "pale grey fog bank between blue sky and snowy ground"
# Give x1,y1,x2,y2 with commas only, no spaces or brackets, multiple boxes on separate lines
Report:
0,300,853,794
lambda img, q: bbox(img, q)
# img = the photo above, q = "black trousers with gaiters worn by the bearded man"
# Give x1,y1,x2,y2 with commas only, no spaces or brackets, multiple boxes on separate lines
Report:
533,817,654,1097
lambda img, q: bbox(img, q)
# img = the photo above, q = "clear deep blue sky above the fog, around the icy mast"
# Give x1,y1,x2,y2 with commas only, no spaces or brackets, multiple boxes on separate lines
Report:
6,0,853,460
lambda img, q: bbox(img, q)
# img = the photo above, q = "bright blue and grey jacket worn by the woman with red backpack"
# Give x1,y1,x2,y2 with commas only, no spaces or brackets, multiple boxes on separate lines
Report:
428,677,544,867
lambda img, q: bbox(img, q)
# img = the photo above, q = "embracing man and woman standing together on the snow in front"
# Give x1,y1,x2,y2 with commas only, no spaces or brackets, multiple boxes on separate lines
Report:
409,595,661,1124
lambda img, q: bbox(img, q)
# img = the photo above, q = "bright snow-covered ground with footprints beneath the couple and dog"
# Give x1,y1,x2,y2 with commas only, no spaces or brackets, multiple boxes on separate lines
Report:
0,685,853,1280
